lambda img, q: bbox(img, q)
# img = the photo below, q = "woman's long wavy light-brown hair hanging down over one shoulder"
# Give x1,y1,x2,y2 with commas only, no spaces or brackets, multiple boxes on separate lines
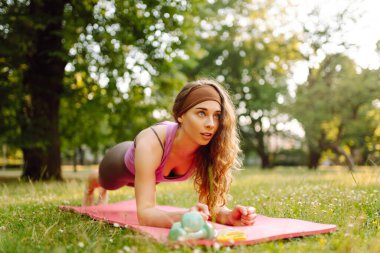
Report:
172,80,241,217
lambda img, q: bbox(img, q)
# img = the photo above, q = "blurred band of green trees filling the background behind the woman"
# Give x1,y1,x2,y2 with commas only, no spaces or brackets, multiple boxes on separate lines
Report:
0,0,380,180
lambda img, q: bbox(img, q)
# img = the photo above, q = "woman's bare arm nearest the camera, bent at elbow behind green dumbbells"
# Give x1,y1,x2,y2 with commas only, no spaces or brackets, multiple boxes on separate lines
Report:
135,129,208,228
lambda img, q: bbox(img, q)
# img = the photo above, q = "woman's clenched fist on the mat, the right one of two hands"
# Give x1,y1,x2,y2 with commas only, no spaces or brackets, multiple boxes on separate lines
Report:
227,205,256,226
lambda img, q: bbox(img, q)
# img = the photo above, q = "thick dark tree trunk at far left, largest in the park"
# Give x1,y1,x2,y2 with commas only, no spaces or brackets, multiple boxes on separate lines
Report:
21,0,66,180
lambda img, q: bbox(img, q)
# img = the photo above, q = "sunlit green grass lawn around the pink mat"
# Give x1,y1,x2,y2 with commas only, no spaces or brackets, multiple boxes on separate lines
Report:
0,168,380,253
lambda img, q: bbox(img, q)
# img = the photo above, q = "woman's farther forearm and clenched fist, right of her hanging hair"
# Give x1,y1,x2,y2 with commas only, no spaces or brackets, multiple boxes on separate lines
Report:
216,205,256,226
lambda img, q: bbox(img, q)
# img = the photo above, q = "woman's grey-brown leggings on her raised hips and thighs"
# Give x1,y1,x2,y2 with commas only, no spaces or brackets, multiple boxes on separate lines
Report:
99,141,134,190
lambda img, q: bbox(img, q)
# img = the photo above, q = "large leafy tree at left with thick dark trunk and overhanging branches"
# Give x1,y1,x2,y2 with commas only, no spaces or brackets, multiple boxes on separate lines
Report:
0,0,202,180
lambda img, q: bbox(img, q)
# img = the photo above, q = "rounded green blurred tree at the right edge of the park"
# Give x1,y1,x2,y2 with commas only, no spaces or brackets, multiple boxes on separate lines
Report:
289,54,380,170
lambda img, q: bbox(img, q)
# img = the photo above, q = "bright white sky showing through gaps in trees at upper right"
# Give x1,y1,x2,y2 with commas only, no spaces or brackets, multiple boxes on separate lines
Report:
282,0,380,137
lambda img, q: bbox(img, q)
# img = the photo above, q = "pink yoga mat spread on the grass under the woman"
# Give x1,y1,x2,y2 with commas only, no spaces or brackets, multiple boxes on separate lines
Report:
60,200,336,245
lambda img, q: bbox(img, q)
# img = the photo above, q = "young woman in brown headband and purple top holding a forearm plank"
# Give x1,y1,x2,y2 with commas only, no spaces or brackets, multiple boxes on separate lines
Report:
84,80,256,227
